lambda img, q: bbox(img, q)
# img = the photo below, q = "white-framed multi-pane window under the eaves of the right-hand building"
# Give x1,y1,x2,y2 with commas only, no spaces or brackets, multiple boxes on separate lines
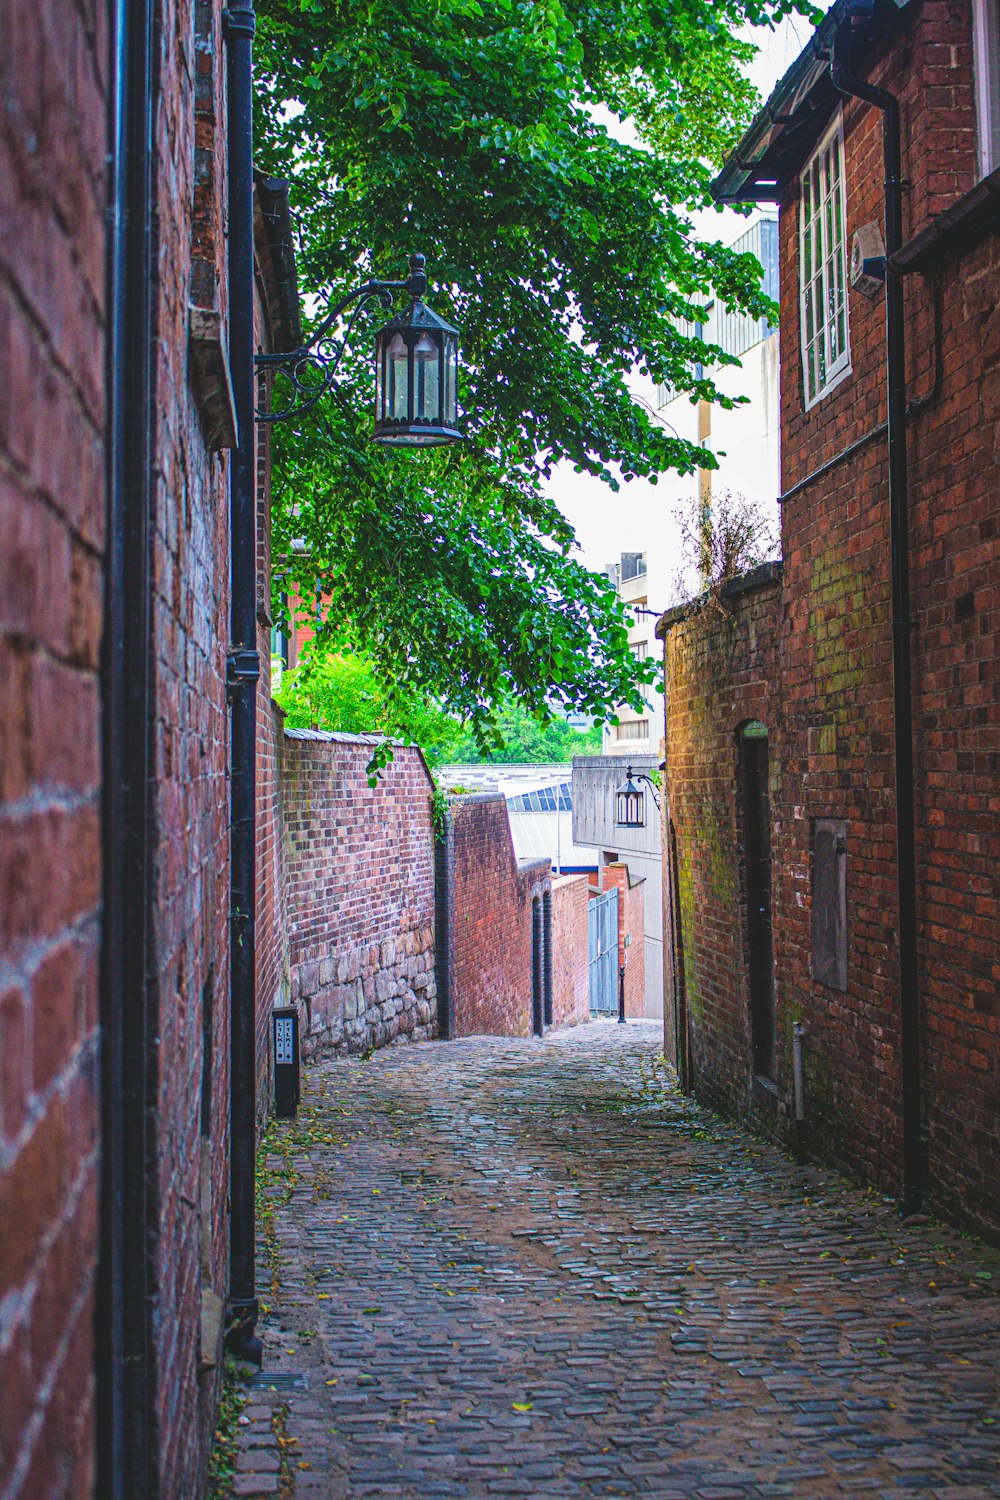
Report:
799,111,850,411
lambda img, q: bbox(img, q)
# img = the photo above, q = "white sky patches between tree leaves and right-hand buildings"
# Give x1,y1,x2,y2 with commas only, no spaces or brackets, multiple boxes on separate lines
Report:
547,0,831,570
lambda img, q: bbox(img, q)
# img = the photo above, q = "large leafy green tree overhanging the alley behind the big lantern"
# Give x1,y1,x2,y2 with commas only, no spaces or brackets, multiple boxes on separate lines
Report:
256,0,804,756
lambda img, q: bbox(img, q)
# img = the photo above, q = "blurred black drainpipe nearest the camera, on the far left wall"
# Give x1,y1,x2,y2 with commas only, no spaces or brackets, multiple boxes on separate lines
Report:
94,0,157,1482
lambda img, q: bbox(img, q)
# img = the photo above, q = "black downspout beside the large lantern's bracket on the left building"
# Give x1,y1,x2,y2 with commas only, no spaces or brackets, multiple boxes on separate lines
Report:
225,3,262,1365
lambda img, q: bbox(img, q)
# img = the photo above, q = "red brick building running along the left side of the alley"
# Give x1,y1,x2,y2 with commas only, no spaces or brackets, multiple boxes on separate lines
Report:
0,0,300,1500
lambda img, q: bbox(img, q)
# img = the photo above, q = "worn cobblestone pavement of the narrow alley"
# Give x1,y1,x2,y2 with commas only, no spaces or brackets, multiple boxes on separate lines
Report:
237,1023,1000,1500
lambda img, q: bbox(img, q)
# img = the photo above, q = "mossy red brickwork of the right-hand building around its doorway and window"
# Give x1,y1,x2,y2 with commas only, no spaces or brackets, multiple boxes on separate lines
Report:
664,0,1000,1233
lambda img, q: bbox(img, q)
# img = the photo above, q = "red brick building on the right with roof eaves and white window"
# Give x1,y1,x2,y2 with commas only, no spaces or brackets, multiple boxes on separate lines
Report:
658,0,1000,1235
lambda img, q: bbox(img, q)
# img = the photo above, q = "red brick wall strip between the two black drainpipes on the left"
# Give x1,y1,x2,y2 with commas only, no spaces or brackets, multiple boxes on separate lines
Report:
151,0,229,1494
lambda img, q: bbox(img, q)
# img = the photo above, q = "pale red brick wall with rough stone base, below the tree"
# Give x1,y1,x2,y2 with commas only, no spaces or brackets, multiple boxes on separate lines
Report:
282,729,436,1056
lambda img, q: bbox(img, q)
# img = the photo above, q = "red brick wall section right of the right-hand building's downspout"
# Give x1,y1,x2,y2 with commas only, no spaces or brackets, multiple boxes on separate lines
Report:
912,239,1000,1233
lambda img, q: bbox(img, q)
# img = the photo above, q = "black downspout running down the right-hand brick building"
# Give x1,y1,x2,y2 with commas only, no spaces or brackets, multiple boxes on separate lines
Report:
831,26,922,1215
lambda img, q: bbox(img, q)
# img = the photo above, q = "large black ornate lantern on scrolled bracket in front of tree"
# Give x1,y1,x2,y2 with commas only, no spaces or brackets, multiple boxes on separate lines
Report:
255,246,462,449
